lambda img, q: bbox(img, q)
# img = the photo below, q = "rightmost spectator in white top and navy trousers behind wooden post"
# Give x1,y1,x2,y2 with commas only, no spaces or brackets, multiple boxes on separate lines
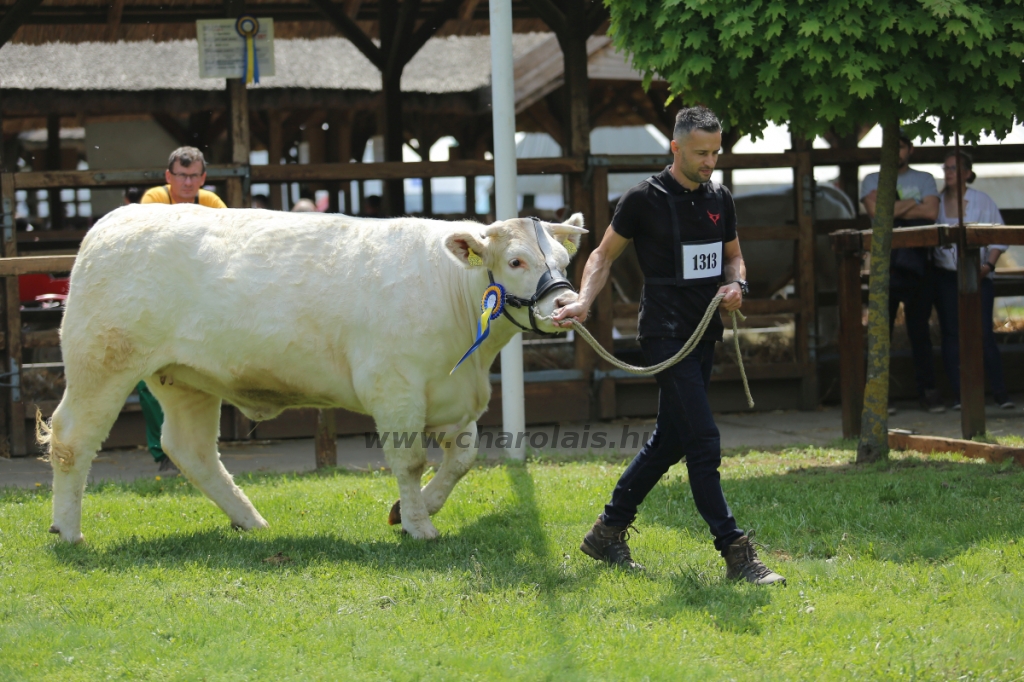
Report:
933,152,1014,410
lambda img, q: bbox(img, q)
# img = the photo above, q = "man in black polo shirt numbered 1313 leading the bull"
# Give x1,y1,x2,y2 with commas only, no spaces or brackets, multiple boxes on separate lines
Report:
553,106,785,585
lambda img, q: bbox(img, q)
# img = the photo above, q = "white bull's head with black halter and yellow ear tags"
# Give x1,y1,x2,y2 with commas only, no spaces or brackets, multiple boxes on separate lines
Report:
444,213,587,334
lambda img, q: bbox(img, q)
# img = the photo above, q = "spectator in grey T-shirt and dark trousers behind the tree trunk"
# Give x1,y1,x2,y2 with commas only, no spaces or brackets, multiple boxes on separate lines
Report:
860,129,946,414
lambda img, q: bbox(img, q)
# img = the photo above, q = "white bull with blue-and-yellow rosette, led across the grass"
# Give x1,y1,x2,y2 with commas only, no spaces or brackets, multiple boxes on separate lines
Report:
39,205,587,542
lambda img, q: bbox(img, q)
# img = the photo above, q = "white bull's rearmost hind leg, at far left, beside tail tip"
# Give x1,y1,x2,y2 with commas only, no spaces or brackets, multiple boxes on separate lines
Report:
45,371,136,543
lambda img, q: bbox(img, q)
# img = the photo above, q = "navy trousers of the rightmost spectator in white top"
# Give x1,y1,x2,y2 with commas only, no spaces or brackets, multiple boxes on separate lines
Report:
934,268,1009,403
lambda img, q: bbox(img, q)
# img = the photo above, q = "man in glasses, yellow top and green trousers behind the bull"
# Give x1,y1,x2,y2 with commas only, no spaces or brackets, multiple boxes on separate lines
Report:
135,146,227,476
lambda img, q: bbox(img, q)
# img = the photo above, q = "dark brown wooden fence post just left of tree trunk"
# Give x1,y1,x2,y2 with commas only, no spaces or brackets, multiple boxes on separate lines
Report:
838,246,866,438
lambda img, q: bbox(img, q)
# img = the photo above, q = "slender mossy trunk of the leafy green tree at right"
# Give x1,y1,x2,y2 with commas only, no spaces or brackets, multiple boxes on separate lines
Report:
857,118,899,464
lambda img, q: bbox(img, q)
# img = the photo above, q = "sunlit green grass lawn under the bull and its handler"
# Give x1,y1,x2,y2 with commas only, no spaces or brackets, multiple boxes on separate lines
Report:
0,443,1024,681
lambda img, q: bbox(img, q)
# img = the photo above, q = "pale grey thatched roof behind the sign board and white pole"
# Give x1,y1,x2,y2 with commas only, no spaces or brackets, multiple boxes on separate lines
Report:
0,34,550,94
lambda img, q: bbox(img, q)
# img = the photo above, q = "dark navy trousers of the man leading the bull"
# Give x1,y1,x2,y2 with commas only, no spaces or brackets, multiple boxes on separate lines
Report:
603,339,743,552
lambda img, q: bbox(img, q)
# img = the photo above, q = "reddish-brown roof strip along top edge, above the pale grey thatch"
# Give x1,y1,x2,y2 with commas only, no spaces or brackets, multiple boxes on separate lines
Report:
0,0,549,45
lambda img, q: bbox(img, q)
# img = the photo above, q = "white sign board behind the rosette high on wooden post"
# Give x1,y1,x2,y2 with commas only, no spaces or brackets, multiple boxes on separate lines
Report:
196,17,274,78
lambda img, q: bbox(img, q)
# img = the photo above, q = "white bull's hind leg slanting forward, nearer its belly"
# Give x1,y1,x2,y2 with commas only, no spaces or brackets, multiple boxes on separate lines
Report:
146,380,267,530
